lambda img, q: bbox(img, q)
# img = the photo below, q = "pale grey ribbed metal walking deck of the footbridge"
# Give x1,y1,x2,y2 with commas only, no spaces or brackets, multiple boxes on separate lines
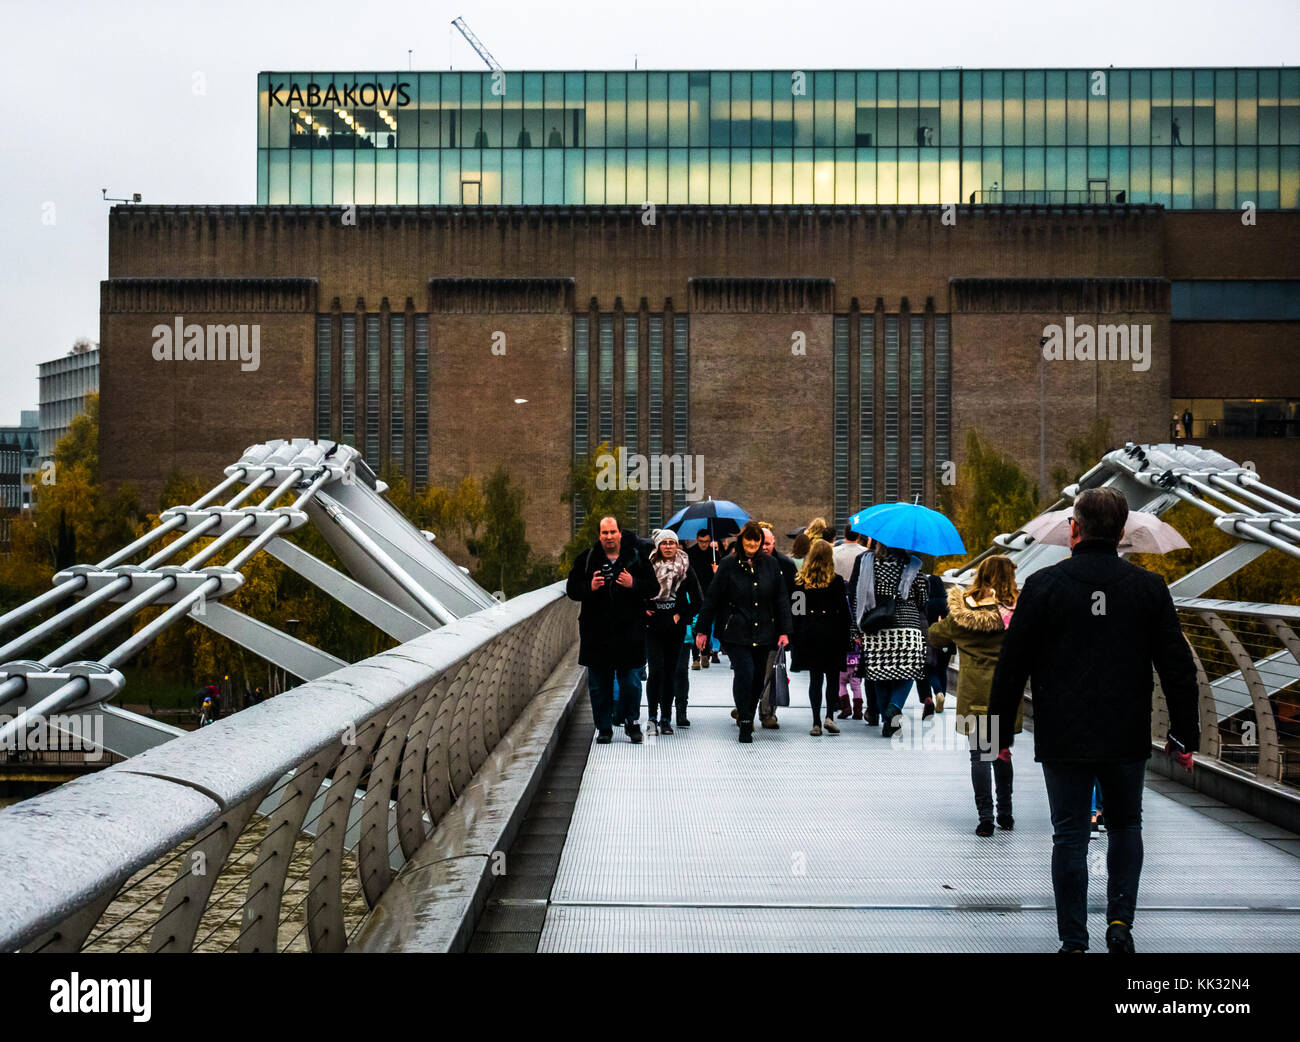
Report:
540,659,1300,951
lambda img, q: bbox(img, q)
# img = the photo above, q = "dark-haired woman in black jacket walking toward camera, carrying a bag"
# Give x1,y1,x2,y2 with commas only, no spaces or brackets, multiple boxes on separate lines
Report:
696,521,790,742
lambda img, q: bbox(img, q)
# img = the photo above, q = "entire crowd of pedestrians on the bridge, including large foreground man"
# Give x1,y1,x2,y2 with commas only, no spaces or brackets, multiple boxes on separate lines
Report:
568,489,1200,952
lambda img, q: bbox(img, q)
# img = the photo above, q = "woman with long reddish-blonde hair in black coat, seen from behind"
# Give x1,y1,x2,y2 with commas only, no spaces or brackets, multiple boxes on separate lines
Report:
790,539,852,738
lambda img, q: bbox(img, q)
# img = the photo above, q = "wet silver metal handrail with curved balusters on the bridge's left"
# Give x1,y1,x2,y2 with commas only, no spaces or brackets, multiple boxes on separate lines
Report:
0,583,576,951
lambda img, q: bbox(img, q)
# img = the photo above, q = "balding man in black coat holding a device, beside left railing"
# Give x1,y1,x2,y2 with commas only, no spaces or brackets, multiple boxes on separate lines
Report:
568,517,659,744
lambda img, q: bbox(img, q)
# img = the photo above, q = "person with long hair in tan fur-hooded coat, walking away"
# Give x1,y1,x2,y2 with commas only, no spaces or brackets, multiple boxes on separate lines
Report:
927,555,1022,835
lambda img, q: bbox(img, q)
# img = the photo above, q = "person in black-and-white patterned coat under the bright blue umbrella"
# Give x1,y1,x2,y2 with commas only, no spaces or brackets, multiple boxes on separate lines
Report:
849,540,930,738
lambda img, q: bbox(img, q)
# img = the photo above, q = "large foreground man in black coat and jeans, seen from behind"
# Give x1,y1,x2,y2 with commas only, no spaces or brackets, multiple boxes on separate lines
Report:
989,489,1200,952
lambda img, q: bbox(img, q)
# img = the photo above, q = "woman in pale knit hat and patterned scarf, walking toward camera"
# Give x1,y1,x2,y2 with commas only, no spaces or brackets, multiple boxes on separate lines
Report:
646,529,702,734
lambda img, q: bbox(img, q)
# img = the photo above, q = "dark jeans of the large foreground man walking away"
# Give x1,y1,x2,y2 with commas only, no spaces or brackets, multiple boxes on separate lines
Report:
1043,760,1147,950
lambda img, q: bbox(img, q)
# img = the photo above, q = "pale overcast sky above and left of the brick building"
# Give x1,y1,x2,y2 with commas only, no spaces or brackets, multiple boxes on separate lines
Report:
0,0,1300,424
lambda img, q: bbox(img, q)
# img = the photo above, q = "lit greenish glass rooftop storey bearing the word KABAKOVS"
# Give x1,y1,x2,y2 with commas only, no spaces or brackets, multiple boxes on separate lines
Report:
257,68,1300,209
